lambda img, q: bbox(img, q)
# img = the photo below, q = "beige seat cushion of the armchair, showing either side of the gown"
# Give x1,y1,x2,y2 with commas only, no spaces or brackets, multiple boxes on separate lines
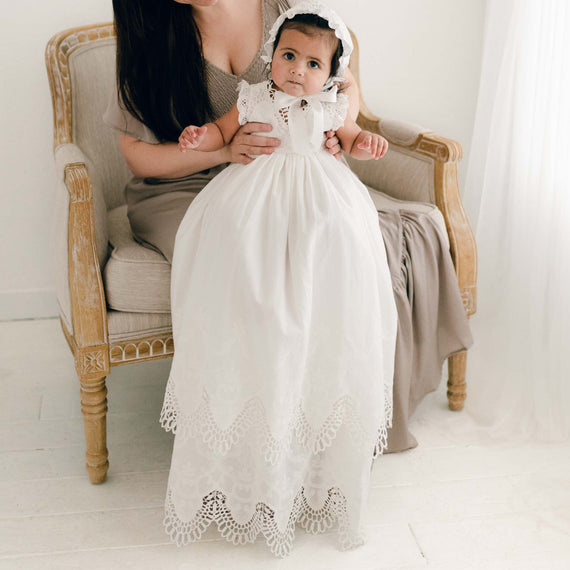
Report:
103,193,449,312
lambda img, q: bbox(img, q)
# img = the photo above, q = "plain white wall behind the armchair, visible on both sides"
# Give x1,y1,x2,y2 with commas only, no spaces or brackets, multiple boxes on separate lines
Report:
0,0,484,320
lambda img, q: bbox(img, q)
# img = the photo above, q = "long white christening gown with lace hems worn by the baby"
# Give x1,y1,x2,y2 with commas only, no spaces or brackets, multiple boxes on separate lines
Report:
161,82,397,556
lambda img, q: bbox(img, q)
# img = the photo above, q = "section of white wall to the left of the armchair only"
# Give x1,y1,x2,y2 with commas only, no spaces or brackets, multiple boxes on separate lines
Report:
0,0,112,319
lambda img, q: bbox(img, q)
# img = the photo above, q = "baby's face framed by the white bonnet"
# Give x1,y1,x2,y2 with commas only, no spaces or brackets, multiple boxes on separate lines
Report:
271,29,334,97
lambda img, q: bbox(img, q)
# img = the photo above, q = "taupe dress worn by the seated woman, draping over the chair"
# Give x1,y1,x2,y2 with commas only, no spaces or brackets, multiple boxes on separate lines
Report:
104,0,472,458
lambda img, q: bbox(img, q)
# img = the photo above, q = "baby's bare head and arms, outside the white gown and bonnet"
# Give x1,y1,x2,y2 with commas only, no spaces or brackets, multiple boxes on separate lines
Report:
179,14,388,160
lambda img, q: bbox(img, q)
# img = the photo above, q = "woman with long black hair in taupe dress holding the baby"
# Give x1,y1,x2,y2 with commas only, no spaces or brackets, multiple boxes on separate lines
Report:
104,0,472,468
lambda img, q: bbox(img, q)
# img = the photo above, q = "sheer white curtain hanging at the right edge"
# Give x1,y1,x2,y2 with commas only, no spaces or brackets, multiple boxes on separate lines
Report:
465,0,570,440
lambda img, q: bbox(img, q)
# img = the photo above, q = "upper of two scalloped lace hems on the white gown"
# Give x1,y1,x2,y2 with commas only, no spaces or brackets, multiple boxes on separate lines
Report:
160,381,392,465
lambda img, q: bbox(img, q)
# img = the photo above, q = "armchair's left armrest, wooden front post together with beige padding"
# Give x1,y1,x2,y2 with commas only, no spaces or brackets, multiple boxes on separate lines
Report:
55,144,108,362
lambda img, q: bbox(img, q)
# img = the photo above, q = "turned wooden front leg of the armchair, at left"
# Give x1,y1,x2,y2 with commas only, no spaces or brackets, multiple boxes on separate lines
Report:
79,376,109,483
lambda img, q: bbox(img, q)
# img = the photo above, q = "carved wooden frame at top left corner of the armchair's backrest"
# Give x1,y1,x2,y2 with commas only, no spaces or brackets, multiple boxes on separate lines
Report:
45,23,115,148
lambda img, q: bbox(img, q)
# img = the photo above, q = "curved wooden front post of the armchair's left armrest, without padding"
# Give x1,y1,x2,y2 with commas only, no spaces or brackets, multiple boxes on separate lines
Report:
64,163,108,349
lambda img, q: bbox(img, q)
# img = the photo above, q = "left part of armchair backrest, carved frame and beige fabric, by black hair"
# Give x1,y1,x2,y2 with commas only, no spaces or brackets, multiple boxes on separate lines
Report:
46,24,132,209
